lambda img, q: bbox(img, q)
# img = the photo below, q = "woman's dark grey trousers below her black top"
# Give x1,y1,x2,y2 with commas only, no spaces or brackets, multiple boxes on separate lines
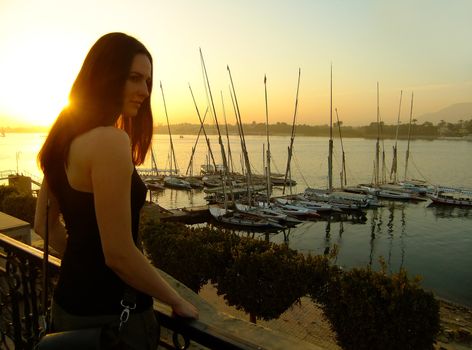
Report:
51,302,160,350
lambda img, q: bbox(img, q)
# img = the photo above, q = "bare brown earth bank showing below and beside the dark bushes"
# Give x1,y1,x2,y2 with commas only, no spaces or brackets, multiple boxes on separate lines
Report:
199,284,472,350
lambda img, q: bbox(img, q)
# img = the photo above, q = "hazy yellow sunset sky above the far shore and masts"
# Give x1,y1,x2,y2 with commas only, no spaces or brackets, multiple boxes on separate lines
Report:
0,0,472,127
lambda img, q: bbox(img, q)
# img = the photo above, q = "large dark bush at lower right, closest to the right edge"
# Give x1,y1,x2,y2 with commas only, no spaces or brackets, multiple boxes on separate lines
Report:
312,268,439,349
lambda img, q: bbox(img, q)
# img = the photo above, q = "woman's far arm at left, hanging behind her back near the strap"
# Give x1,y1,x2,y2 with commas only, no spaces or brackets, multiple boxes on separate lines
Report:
34,179,67,257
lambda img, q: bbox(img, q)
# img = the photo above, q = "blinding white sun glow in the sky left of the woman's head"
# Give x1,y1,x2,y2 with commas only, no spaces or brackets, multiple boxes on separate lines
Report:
0,32,83,126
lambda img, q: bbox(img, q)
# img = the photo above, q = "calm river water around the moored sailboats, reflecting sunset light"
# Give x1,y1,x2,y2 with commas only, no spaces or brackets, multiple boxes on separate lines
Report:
0,134,472,307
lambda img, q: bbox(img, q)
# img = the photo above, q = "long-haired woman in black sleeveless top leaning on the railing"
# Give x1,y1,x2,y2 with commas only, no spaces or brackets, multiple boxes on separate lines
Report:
34,33,198,349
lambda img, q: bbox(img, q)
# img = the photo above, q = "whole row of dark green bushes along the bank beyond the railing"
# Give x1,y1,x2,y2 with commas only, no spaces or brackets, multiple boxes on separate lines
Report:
141,221,439,349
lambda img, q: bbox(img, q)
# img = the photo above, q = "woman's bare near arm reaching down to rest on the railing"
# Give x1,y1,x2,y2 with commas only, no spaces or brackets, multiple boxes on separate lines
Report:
90,128,198,318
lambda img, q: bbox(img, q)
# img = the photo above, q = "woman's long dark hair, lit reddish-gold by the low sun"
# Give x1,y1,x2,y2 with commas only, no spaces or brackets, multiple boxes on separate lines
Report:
38,33,153,185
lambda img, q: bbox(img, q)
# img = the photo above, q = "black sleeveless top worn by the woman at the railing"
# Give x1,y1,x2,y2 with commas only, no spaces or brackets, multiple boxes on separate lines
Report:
54,165,153,316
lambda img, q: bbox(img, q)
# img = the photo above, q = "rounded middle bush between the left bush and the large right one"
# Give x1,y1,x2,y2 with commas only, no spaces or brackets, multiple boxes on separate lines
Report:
217,239,306,320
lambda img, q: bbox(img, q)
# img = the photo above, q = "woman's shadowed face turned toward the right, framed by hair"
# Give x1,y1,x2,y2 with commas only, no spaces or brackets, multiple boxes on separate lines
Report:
122,54,152,118
